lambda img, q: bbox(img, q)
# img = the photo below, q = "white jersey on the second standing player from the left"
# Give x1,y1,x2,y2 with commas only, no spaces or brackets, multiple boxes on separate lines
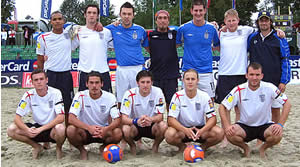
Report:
73,26,112,73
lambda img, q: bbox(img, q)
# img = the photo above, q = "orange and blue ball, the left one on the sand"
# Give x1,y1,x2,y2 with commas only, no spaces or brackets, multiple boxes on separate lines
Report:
103,144,123,163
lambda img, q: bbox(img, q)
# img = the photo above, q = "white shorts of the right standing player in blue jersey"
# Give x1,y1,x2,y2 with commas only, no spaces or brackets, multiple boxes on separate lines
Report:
182,73,216,97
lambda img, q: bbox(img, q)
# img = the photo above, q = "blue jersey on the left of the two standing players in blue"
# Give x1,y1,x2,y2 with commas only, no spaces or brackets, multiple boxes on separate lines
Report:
106,24,148,66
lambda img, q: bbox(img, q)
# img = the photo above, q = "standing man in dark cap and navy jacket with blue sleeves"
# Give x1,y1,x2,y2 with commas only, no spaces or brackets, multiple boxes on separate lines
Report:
248,11,291,123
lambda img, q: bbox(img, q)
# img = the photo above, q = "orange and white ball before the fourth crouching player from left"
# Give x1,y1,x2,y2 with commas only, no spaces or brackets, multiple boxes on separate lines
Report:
183,145,204,163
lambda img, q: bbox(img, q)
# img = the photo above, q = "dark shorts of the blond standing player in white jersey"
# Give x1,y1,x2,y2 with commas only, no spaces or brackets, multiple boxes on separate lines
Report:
215,75,247,104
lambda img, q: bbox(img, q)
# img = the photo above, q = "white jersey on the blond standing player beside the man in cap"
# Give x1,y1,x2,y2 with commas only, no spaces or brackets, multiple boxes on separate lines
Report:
218,26,254,75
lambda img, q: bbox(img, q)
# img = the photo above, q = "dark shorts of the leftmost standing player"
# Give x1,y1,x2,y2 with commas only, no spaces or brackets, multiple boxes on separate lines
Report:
46,70,74,113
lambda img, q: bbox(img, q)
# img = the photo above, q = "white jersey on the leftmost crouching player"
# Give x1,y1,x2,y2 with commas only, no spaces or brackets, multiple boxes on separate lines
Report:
16,86,64,125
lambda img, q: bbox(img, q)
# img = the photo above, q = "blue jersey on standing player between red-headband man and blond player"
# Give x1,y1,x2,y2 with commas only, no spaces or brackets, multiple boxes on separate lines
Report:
176,21,220,73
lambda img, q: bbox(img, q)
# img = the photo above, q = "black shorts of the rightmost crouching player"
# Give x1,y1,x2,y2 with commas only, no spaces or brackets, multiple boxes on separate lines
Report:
236,122,274,142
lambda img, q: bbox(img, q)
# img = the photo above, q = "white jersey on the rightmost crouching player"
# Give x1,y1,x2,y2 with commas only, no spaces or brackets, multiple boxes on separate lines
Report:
222,81,287,126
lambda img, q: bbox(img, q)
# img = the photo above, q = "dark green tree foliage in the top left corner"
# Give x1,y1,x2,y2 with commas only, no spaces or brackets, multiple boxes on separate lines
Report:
1,0,15,23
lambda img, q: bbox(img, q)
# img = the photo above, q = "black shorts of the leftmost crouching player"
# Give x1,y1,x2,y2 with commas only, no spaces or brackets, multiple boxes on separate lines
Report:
25,123,56,143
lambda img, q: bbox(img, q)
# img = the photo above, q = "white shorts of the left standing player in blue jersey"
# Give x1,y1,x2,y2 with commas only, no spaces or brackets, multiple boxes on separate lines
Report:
116,65,143,103
